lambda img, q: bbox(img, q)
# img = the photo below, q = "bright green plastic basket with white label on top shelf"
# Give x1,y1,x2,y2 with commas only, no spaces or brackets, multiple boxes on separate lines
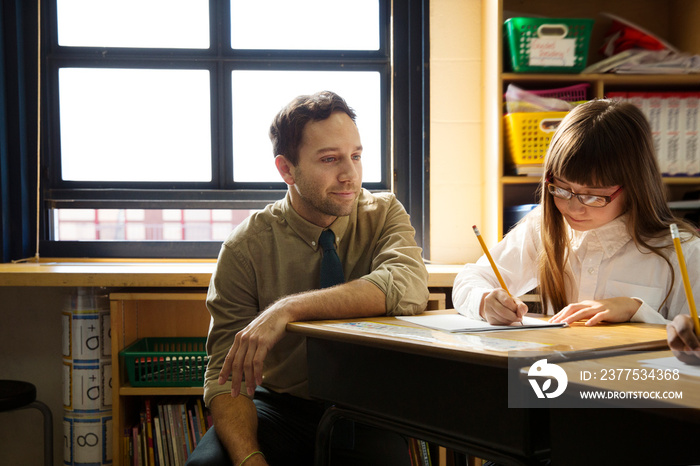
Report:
503,18,594,73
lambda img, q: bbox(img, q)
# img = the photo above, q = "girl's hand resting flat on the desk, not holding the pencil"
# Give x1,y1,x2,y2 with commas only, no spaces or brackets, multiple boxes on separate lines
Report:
549,298,642,326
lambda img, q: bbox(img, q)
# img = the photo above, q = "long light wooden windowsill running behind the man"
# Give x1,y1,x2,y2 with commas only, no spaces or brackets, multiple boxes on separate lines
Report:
0,259,462,288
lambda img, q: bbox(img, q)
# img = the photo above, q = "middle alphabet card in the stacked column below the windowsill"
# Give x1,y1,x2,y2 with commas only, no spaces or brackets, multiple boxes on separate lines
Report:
63,360,112,412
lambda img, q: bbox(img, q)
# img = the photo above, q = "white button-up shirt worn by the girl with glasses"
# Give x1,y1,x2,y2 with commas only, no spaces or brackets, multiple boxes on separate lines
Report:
452,207,700,324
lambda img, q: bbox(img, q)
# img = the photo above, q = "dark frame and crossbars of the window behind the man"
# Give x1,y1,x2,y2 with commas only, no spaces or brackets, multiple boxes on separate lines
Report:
39,0,429,258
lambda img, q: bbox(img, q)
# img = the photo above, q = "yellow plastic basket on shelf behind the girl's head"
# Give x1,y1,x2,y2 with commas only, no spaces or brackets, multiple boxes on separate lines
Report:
503,112,568,167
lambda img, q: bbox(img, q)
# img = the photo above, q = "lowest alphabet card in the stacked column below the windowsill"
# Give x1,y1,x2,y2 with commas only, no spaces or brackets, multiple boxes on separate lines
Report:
63,413,112,465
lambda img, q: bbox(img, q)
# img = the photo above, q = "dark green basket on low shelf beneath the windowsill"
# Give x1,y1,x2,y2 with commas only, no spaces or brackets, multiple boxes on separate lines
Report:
119,337,208,387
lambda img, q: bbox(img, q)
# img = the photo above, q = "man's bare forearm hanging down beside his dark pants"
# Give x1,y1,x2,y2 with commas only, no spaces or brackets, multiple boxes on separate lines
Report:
209,394,260,464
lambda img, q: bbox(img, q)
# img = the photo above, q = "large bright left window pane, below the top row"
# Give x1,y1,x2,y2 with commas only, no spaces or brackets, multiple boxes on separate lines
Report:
59,68,212,182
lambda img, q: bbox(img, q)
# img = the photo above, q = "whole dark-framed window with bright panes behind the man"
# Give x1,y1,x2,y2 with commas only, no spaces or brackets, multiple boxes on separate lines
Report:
41,0,427,257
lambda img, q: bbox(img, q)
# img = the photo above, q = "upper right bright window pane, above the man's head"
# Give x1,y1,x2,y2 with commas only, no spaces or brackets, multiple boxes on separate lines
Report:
231,0,379,50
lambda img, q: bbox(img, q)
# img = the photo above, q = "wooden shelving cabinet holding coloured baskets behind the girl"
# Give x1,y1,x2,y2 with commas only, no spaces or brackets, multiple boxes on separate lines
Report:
482,0,700,242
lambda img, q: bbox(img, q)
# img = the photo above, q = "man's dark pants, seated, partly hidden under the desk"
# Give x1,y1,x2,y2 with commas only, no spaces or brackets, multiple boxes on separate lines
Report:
187,387,411,466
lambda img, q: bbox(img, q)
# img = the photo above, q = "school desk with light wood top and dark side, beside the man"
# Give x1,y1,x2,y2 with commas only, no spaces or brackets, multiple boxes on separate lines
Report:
287,317,666,464
